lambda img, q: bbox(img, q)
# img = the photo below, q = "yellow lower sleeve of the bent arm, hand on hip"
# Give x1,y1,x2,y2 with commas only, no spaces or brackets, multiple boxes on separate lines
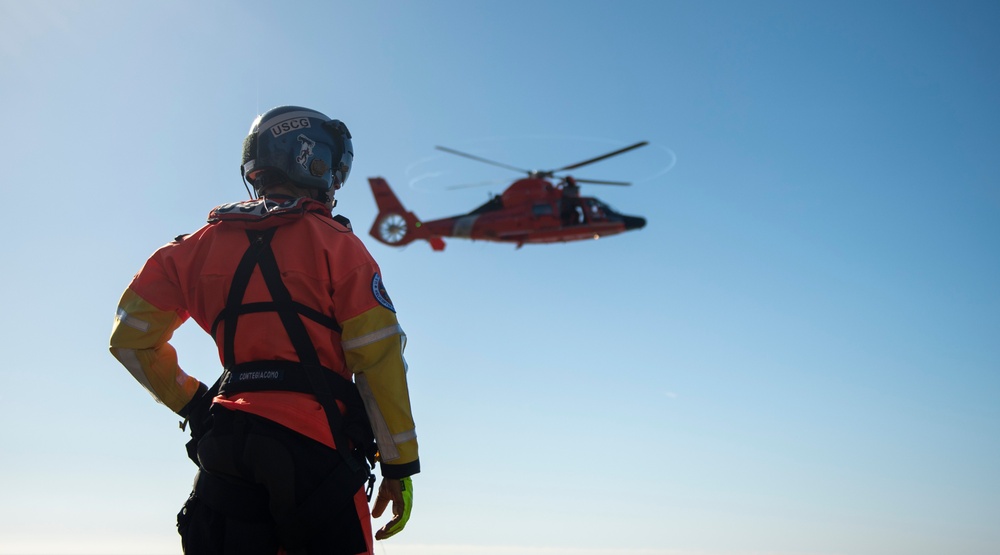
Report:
111,289,199,412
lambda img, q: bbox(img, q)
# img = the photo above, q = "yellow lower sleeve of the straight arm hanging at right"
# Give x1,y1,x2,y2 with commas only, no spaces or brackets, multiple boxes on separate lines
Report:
341,306,418,465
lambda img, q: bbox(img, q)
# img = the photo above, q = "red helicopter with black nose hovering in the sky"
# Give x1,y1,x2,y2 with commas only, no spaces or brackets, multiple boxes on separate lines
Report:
368,141,649,251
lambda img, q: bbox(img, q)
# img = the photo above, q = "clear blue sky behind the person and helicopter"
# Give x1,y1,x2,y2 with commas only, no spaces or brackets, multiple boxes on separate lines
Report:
0,0,1000,555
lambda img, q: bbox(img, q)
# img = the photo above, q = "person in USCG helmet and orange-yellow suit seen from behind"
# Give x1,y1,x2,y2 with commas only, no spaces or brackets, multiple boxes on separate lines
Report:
111,106,420,555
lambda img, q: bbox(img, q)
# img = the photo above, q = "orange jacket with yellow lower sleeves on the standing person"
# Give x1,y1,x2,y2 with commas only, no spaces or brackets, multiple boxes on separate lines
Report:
111,196,420,551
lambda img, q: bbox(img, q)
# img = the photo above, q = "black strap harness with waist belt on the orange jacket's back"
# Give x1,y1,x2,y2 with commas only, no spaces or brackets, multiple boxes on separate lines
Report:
208,227,376,482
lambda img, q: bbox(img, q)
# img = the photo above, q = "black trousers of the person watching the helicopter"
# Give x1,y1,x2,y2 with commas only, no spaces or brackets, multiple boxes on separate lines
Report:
177,408,370,555
